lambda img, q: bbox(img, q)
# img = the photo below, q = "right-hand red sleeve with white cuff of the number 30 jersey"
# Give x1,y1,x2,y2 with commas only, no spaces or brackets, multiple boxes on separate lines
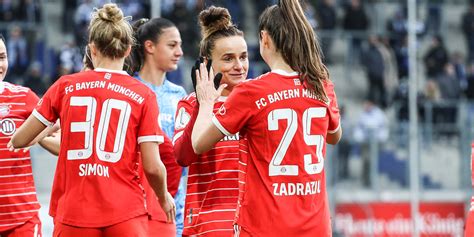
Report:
138,91,164,144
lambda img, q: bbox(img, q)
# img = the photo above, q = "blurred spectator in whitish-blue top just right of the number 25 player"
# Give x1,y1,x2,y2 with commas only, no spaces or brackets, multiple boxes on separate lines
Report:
353,99,389,186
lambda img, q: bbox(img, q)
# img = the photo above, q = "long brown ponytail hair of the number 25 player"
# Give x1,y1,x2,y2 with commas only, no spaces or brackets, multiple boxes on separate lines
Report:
258,0,329,101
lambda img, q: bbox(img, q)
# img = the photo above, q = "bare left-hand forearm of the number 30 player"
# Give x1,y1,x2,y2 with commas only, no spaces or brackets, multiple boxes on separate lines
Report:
10,115,46,149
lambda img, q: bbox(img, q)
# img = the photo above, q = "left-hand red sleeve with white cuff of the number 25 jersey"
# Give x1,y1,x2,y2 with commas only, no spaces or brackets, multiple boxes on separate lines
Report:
212,83,257,136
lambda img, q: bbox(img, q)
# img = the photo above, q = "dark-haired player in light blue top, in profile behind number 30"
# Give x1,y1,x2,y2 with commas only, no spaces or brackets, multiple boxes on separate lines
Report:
130,18,186,237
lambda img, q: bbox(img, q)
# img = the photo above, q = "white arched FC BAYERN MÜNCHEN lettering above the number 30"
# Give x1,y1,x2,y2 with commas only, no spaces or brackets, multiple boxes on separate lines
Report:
64,81,145,104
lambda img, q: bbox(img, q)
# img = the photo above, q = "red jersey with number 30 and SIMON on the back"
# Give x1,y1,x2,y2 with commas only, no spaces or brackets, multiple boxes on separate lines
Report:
33,69,163,228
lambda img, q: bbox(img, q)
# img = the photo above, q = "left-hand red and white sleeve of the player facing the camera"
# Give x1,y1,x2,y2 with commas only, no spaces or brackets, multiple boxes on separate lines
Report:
173,95,199,166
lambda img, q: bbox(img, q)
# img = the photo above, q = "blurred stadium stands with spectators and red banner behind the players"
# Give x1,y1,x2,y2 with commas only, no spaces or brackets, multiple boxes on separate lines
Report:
0,0,474,236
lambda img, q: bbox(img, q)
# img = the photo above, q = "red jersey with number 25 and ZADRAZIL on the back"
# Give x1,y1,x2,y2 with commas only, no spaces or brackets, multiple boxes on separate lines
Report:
213,70,339,236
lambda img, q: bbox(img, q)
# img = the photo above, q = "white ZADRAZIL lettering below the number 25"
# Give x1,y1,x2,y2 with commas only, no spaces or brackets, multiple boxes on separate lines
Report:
272,180,321,196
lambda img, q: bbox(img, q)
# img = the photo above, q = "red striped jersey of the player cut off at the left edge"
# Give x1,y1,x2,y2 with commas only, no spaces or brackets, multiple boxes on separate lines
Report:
0,81,40,232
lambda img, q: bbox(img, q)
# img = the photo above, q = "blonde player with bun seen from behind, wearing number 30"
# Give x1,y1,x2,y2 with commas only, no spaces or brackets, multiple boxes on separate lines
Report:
11,4,175,237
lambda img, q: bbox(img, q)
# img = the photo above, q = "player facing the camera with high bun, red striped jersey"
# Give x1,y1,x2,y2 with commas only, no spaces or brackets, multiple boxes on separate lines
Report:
174,6,249,236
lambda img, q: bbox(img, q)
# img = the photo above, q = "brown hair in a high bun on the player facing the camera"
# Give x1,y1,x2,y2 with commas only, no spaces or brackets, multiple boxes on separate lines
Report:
199,6,244,58
